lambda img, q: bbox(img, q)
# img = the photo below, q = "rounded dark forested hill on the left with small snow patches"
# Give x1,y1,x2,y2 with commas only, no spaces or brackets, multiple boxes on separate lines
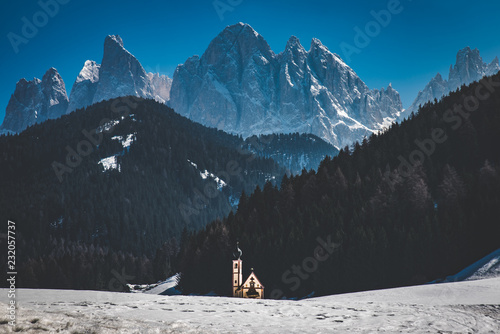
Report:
0,97,285,290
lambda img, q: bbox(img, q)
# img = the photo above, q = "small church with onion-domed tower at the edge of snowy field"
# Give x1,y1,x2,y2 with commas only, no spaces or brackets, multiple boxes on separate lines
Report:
233,241,264,299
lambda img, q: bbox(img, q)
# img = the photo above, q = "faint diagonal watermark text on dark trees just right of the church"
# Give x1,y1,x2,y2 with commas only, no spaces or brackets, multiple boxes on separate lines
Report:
269,235,340,299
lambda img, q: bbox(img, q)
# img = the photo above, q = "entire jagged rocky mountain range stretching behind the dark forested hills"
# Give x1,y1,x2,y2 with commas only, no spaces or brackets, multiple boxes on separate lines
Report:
0,23,500,148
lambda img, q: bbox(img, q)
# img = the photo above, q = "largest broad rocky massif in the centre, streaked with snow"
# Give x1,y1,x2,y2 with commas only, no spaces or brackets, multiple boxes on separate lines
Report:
169,23,402,147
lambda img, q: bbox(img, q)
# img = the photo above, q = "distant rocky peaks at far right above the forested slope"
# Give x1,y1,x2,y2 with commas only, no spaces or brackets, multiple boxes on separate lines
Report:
405,46,500,114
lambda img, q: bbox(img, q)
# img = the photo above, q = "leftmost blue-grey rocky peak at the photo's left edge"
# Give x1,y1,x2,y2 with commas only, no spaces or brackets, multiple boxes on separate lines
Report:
0,68,68,133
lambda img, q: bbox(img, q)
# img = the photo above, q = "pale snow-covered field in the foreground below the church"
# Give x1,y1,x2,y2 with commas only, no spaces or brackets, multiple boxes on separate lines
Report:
0,278,500,334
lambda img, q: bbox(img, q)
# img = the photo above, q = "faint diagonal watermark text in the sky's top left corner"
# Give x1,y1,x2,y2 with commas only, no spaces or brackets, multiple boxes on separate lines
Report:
7,0,71,54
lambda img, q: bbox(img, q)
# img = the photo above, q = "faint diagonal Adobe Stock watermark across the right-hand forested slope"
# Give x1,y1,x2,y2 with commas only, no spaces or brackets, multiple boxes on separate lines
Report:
384,77,500,191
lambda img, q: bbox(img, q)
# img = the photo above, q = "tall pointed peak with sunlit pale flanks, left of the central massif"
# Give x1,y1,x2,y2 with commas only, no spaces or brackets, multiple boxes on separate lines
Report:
68,35,172,112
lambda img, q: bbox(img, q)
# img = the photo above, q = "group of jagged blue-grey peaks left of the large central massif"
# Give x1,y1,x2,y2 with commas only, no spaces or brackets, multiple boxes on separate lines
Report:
0,35,172,133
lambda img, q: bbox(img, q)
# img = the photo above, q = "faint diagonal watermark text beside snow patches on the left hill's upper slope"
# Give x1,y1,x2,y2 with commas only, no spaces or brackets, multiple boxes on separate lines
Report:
52,96,138,182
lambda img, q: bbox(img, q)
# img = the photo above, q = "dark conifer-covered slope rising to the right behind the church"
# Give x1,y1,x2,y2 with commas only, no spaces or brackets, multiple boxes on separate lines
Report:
180,75,500,298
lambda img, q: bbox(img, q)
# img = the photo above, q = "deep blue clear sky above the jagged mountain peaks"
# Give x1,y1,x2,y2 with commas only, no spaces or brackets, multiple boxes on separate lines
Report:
0,0,500,120
